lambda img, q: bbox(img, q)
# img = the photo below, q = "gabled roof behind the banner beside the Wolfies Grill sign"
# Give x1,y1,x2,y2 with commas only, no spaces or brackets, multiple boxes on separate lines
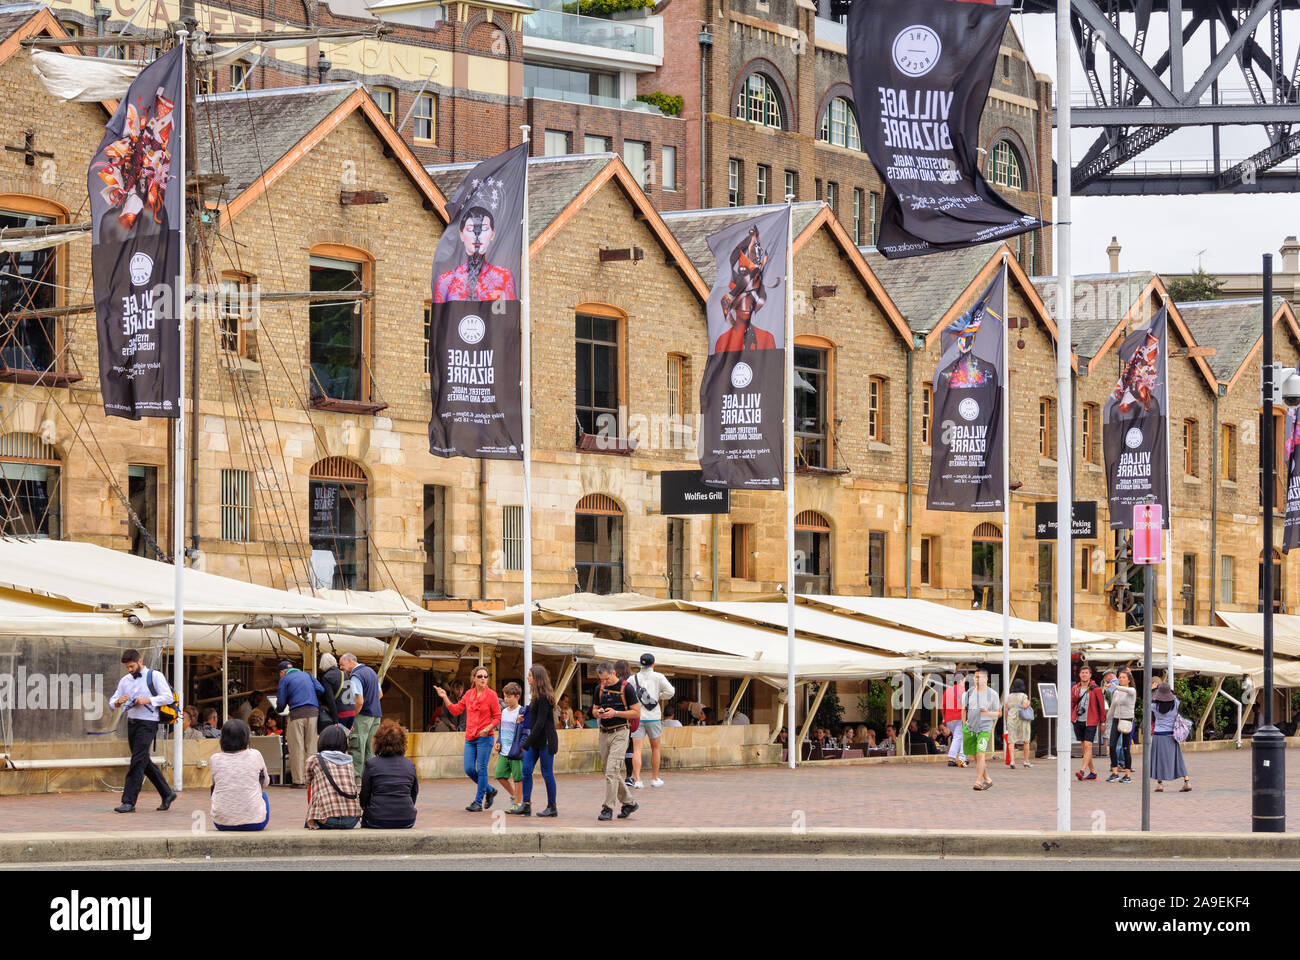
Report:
663,200,913,350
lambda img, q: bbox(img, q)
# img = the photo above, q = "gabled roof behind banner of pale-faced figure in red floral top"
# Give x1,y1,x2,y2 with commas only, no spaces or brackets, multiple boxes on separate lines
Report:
425,153,709,302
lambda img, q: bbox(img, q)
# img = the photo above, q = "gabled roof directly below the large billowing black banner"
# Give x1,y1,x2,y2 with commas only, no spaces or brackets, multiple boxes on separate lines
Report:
865,243,1079,369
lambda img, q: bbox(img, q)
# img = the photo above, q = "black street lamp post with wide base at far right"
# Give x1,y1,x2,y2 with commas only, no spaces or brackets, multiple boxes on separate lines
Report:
1251,254,1287,834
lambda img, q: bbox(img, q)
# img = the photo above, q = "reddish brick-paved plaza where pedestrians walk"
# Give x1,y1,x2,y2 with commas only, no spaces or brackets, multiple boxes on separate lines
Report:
0,745,1300,834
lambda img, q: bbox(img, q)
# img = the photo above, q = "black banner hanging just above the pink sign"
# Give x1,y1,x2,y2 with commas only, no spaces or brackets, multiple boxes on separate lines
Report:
1101,307,1169,529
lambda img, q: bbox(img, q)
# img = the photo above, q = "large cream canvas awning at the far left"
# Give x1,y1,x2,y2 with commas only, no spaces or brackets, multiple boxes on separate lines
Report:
0,540,413,636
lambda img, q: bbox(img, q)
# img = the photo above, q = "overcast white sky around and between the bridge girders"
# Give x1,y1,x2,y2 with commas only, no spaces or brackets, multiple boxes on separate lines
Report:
1011,14,1300,273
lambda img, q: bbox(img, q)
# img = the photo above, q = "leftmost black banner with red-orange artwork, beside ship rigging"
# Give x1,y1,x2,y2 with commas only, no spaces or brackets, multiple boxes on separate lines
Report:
87,47,185,420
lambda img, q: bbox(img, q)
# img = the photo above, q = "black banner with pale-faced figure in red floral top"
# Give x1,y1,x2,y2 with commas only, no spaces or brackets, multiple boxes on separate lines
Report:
429,143,528,460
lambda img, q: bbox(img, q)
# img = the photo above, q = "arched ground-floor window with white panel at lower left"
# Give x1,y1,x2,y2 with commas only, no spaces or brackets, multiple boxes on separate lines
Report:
308,457,371,591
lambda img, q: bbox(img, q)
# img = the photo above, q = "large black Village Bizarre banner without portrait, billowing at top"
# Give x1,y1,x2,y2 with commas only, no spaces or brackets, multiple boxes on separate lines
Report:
849,0,1044,260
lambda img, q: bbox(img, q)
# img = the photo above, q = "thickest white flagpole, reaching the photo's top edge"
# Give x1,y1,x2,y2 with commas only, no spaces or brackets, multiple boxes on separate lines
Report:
1056,0,1074,830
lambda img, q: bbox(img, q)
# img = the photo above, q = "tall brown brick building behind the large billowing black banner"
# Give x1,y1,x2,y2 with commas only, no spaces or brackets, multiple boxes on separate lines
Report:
638,0,1052,274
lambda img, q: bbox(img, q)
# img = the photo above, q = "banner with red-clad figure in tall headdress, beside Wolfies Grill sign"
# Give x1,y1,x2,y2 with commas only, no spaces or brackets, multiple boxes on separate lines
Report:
699,207,790,490
